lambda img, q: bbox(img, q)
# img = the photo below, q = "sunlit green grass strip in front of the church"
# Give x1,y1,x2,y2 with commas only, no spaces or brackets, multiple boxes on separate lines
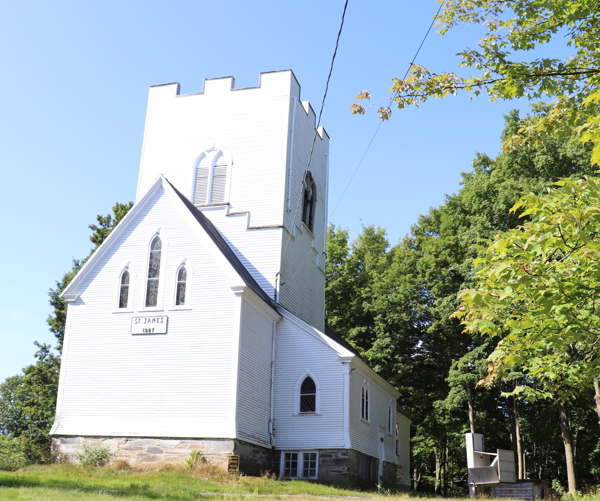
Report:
0,464,422,501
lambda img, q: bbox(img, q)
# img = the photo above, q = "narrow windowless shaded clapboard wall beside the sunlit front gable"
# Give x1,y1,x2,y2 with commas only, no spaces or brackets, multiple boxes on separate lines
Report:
237,300,273,447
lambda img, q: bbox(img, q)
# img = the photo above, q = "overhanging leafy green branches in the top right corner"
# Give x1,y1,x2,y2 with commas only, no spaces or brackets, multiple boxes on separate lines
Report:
352,0,600,163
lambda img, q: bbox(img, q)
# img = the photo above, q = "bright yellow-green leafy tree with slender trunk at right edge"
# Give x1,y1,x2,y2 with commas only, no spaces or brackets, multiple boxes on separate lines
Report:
455,178,600,490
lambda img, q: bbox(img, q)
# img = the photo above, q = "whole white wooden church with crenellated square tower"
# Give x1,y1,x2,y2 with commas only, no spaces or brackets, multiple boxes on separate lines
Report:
51,70,410,483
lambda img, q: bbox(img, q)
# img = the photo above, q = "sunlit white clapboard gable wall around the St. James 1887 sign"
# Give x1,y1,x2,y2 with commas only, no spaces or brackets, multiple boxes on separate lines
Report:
55,188,235,437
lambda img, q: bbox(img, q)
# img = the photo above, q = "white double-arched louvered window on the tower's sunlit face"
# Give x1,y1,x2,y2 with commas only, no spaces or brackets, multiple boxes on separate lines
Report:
193,147,231,205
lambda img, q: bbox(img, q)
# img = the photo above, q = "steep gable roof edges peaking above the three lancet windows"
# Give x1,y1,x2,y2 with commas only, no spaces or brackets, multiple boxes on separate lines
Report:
62,175,277,311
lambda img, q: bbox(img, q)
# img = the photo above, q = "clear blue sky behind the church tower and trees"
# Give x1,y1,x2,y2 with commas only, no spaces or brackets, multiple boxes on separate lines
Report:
0,0,527,381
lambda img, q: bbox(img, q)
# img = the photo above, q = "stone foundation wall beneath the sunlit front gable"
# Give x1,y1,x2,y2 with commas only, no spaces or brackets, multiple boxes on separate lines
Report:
52,436,272,475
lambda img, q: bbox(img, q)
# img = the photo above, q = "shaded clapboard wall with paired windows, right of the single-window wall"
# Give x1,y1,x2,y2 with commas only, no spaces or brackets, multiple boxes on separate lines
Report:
350,362,396,463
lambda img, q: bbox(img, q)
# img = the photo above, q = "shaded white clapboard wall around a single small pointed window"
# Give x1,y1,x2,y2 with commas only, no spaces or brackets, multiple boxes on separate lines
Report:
274,312,345,449
